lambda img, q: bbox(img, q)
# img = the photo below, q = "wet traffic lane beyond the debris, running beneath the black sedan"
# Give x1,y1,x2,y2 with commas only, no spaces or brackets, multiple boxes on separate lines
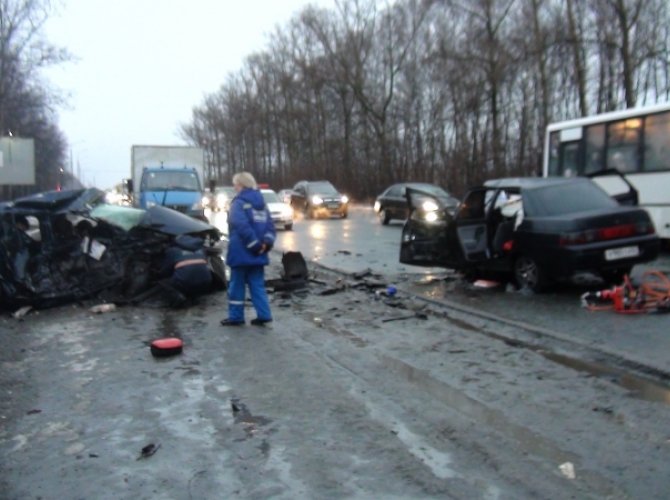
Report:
276,206,670,371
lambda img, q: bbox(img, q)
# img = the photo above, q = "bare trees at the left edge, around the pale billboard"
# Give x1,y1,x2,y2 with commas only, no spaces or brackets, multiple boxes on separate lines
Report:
0,0,69,201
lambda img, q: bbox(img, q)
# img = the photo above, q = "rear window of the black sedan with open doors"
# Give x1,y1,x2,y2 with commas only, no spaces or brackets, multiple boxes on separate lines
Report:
523,182,618,216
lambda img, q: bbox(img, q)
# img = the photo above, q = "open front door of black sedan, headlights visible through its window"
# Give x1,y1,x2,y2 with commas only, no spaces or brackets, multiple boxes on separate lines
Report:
400,187,454,267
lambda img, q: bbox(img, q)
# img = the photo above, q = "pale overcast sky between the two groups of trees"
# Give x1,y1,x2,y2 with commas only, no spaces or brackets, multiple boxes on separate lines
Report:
46,0,335,189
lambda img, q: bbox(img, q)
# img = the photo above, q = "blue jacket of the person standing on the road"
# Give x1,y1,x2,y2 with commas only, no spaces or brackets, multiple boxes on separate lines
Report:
226,188,276,267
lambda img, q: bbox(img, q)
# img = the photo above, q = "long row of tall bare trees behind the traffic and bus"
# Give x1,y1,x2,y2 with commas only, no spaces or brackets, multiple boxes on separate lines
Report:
181,0,670,200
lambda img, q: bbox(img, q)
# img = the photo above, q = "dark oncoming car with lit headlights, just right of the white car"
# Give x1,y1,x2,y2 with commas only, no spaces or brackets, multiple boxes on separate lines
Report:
291,181,349,219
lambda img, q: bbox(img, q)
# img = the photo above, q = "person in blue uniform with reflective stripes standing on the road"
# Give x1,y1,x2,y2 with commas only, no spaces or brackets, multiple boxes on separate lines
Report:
221,172,276,326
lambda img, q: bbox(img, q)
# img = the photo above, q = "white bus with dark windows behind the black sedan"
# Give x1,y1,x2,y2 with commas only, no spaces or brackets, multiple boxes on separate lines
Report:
542,102,670,240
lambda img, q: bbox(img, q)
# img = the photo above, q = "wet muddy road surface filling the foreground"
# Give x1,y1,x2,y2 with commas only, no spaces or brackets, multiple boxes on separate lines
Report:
0,259,670,499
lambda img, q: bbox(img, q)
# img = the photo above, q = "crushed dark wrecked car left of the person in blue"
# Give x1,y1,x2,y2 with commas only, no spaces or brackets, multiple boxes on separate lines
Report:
0,188,226,309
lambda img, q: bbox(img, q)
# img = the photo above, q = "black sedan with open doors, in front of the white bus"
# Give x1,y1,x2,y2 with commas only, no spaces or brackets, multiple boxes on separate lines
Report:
400,178,660,292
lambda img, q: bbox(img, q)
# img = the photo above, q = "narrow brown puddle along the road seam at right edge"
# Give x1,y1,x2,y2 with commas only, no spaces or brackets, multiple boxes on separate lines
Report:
537,350,670,404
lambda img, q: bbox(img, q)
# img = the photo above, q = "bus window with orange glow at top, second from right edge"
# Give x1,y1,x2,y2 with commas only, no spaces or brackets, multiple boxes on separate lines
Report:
607,118,642,173
